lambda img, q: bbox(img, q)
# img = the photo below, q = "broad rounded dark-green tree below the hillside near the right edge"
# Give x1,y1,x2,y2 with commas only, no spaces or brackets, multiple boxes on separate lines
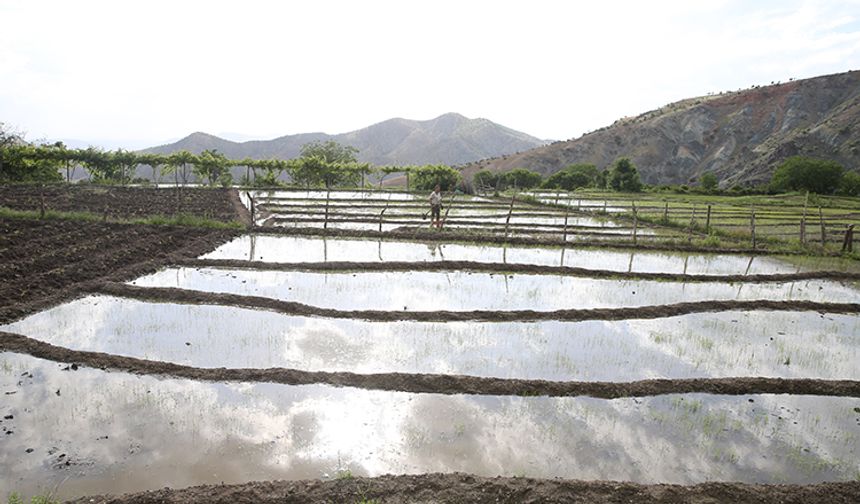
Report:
770,156,845,194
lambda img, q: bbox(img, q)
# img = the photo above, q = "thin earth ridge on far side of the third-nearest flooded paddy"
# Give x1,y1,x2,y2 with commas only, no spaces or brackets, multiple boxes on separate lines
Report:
175,259,860,283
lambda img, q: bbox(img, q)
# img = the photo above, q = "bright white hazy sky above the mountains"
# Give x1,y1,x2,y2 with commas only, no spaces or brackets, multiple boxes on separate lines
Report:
0,0,860,148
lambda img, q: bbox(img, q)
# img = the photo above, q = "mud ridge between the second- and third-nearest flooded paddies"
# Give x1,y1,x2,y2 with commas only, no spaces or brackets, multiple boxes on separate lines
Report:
94,282,860,322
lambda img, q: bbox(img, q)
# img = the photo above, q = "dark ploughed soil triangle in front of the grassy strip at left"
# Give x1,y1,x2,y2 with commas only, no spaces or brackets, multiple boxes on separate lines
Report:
0,219,237,322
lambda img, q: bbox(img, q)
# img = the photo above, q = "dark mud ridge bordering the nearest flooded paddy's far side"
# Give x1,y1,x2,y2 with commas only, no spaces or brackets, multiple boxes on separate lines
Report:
0,331,860,399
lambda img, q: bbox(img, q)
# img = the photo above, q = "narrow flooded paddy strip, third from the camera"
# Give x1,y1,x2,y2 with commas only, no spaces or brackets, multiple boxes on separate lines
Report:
131,267,860,311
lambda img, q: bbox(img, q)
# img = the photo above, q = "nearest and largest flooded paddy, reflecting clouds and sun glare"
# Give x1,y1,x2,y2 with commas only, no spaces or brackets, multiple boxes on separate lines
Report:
0,353,860,497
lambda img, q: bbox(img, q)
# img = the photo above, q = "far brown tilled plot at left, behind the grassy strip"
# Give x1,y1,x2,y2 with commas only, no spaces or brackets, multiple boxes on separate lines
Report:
0,185,244,222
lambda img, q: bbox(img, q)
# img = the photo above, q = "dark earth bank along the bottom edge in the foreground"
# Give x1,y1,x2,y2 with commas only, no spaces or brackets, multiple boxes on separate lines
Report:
65,473,860,504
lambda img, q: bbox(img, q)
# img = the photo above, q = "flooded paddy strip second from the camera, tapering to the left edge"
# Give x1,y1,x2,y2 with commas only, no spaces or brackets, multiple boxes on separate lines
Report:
0,296,860,381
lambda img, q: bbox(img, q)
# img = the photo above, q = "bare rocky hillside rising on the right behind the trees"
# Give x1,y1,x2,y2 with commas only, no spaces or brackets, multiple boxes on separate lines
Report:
464,71,860,187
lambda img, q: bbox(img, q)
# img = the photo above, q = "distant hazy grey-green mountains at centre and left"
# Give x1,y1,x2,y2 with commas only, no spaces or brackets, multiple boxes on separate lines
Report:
143,113,545,165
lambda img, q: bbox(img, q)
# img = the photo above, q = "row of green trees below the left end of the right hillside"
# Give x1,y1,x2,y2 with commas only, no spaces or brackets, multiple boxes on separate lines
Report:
472,157,642,192
